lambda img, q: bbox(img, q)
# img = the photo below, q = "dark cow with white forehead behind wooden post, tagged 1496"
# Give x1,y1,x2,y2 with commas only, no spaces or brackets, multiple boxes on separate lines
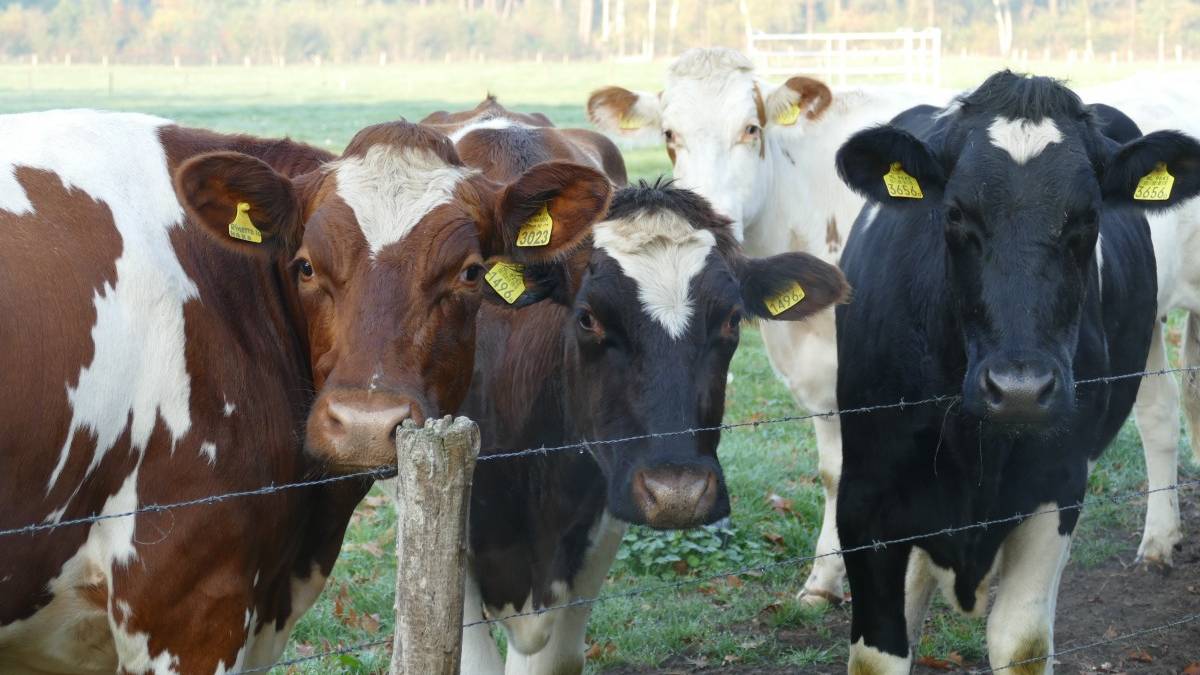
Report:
463,184,847,674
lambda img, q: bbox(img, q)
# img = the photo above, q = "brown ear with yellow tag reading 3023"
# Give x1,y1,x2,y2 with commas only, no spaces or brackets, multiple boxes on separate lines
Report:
485,161,612,264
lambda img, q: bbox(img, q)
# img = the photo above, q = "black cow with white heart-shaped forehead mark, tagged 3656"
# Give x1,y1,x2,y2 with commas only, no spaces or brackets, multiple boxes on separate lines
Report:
838,71,1200,673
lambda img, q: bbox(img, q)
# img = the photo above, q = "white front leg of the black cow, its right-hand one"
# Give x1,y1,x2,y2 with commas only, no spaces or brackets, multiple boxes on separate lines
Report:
988,503,1070,675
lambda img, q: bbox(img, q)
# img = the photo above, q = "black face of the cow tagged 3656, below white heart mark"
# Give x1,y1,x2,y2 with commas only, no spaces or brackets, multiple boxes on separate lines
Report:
935,118,1102,423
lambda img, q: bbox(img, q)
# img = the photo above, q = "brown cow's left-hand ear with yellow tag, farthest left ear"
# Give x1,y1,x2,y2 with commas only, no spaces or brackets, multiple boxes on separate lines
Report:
175,153,302,253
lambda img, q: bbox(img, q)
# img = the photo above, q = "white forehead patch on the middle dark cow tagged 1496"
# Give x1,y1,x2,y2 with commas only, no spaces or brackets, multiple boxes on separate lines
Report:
593,210,716,340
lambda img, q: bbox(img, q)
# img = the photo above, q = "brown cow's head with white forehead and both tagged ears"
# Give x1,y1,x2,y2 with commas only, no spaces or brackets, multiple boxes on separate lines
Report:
176,123,611,470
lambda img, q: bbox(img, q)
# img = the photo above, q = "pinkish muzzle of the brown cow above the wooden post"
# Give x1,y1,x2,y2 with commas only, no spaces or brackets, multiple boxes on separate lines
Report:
306,392,425,471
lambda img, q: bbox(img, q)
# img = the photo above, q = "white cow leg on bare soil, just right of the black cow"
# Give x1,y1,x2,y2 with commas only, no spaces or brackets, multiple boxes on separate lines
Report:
1134,322,1183,566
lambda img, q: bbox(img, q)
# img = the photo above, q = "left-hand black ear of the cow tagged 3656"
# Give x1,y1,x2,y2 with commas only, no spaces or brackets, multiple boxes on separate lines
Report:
838,125,946,207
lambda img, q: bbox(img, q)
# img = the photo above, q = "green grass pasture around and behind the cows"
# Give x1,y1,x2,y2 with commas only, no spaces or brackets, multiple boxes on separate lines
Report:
7,59,1200,673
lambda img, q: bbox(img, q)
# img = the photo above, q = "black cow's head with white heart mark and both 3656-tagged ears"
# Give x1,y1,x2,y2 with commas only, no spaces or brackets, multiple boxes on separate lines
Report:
838,71,1200,423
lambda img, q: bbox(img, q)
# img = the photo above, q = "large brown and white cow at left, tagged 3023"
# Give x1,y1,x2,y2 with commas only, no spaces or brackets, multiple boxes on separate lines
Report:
0,110,611,674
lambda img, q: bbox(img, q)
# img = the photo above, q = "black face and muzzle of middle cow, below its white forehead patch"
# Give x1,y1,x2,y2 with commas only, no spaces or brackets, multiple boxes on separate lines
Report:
564,250,744,528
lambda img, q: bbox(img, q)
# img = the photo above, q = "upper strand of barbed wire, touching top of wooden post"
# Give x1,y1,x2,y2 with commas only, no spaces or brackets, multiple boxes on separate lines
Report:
0,366,1200,537
